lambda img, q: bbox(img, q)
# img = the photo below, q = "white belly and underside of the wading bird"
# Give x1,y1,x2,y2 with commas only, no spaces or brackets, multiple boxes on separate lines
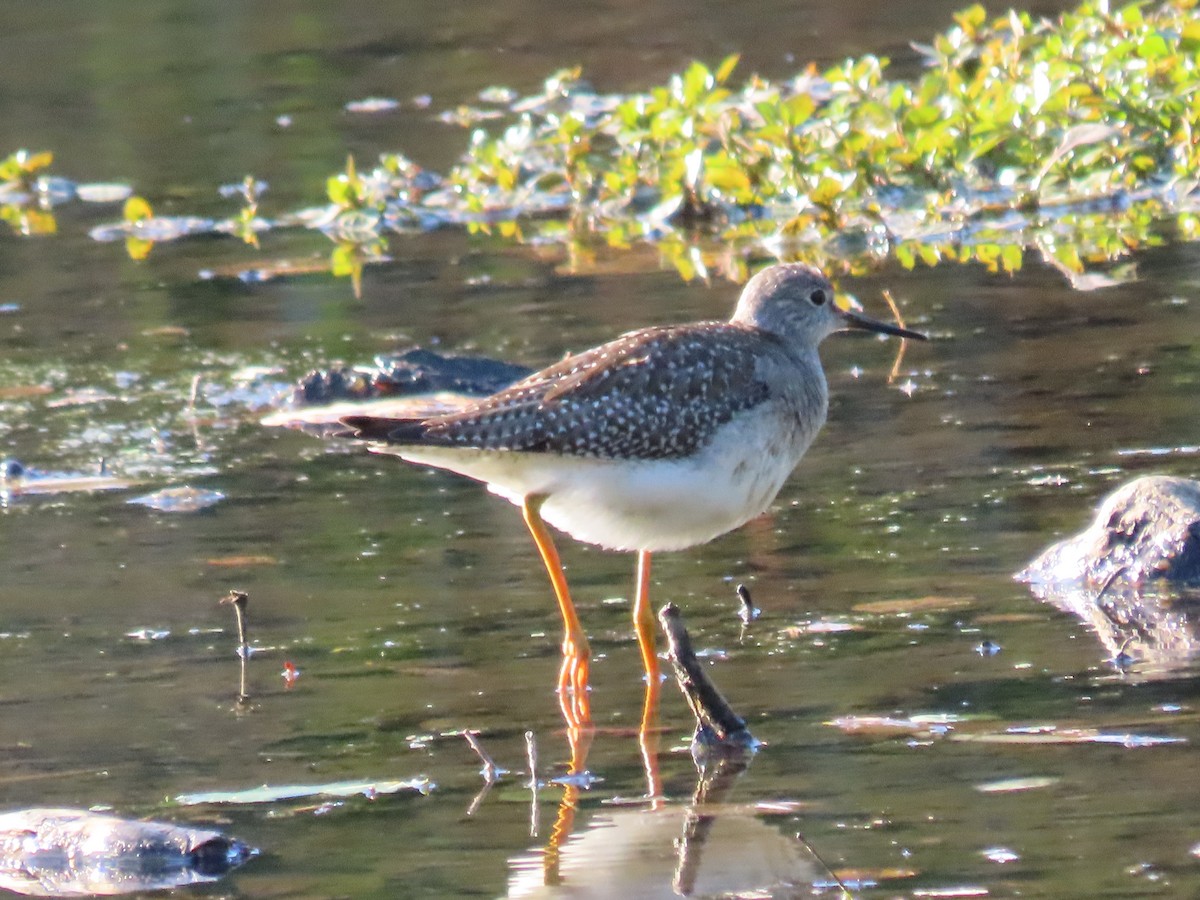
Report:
376,408,820,552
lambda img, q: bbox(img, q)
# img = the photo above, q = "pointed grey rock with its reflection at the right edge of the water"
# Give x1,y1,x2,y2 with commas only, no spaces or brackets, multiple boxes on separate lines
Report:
1016,475,1200,670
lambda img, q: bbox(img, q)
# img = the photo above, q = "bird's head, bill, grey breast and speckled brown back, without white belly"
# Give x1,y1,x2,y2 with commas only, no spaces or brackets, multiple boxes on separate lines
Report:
343,264,921,480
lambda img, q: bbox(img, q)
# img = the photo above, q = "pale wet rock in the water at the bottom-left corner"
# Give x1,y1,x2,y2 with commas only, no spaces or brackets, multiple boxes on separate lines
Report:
0,809,258,896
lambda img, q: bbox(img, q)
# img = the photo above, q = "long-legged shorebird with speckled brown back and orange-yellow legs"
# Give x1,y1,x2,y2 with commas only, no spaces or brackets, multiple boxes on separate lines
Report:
342,263,925,718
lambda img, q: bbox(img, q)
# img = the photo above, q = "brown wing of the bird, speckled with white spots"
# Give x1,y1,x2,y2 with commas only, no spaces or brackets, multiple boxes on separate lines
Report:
346,323,784,460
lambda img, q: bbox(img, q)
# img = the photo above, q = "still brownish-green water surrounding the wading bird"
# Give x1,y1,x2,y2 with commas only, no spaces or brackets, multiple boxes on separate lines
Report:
0,1,1200,898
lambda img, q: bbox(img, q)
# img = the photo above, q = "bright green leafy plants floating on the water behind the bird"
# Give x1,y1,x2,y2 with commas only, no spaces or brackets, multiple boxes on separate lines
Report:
0,0,1200,287
